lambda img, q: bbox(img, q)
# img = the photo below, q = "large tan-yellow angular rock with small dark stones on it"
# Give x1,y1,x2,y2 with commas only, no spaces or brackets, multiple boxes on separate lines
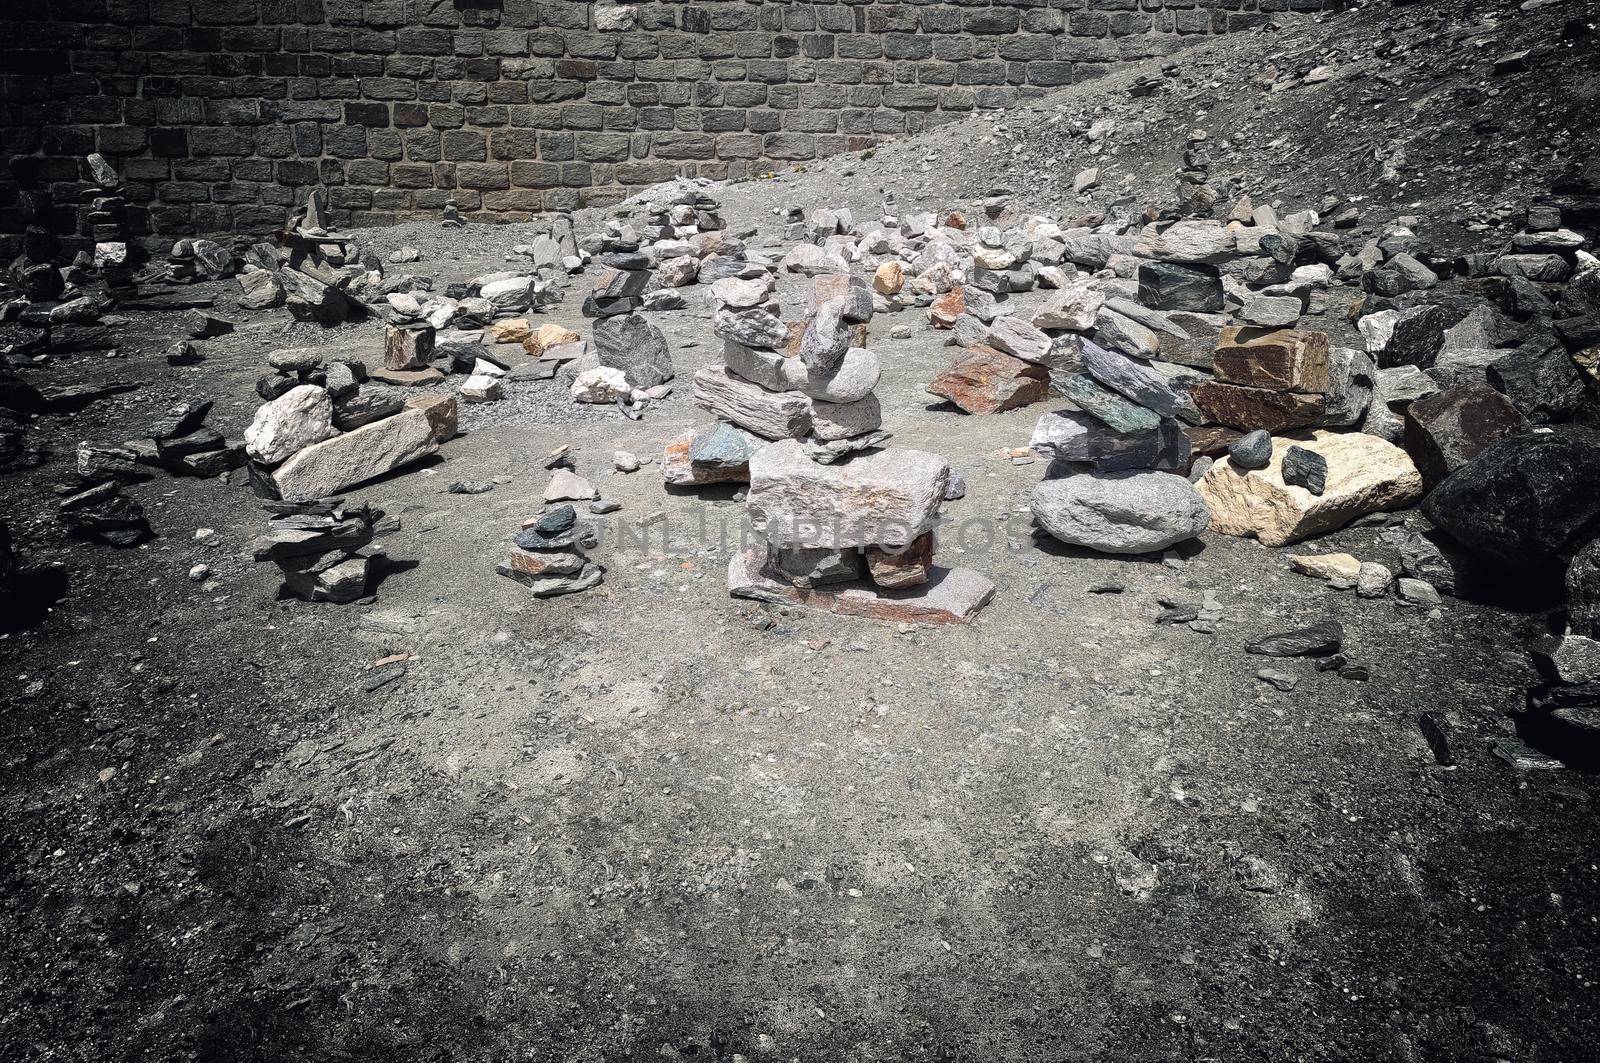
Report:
1197,431,1422,546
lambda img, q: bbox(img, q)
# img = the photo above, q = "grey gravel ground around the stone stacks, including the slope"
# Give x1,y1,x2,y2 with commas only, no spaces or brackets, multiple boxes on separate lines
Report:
0,5,1600,1060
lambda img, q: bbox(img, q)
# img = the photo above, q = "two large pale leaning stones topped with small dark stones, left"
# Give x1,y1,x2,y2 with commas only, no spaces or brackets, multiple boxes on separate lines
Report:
245,347,456,501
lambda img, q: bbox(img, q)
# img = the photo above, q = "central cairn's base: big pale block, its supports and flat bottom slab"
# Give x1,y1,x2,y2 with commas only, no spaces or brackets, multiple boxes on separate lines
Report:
728,440,994,624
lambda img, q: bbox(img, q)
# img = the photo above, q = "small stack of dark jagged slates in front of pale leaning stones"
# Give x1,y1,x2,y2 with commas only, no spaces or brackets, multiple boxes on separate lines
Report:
253,498,400,605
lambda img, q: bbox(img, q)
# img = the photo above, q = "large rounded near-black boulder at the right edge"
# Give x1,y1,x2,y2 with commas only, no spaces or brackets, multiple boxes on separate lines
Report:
1422,427,1600,570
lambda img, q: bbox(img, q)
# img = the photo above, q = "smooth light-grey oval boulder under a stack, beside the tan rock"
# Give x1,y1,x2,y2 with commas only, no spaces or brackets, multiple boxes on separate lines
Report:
1032,471,1211,554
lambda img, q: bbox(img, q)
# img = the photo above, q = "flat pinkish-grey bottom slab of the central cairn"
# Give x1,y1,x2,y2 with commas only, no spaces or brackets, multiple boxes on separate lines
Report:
728,548,995,624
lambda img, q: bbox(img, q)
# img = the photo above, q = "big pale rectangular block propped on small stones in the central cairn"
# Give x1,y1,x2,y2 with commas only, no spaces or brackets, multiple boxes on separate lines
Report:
746,440,950,549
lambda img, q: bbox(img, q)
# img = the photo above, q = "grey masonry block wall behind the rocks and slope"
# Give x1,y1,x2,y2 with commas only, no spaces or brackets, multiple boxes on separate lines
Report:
0,0,1338,251
